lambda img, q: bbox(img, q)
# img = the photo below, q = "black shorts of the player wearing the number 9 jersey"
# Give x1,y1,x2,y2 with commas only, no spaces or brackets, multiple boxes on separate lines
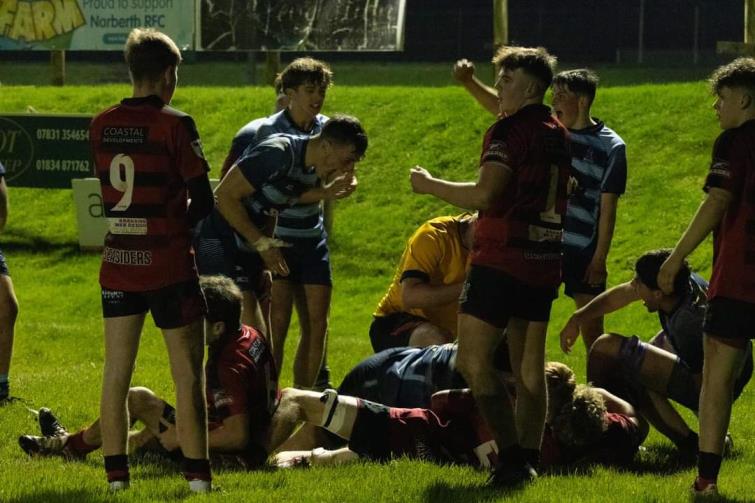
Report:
102,280,207,329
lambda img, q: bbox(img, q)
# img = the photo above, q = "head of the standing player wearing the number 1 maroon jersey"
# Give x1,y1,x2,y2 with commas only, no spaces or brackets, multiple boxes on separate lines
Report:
493,46,556,115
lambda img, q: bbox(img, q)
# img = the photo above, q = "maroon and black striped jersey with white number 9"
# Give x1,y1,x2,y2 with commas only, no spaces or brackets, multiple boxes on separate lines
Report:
89,96,209,292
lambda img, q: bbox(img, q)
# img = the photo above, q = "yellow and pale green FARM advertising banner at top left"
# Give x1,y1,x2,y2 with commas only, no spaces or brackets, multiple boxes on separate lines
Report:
0,0,196,51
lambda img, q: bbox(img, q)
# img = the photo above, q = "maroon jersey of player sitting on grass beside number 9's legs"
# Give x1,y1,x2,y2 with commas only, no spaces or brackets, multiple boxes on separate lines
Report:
205,325,280,445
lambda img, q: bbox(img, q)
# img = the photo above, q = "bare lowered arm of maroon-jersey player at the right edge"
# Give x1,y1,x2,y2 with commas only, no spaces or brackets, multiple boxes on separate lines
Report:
658,187,732,294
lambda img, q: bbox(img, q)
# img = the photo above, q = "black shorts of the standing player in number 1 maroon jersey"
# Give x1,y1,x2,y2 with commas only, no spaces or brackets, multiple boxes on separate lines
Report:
459,265,558,329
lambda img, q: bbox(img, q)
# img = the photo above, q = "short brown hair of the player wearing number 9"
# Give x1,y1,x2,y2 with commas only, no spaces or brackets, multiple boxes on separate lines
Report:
123,28,181,82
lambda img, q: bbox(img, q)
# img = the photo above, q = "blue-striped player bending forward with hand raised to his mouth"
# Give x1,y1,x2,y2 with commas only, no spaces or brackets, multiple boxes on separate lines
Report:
196,115,367,388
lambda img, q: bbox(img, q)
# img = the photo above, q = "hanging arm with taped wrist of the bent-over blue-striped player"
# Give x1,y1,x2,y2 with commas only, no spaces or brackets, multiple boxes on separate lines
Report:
215,164,288,276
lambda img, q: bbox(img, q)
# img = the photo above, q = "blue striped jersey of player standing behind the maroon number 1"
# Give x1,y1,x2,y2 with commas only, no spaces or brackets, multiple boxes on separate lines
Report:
564,119,627,257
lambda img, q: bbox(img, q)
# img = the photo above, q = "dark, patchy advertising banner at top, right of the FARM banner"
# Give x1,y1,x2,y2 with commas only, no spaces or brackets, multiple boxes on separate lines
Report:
201,0,406,51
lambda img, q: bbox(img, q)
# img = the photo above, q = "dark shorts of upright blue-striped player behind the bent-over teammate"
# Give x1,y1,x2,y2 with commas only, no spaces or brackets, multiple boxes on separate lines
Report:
275,237,333,286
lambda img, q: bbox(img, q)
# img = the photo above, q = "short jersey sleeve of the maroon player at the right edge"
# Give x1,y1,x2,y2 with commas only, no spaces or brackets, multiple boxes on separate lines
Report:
703,130,748,198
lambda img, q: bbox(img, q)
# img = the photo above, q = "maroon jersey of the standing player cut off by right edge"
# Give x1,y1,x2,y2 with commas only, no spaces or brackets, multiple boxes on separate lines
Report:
705,120,755,304
